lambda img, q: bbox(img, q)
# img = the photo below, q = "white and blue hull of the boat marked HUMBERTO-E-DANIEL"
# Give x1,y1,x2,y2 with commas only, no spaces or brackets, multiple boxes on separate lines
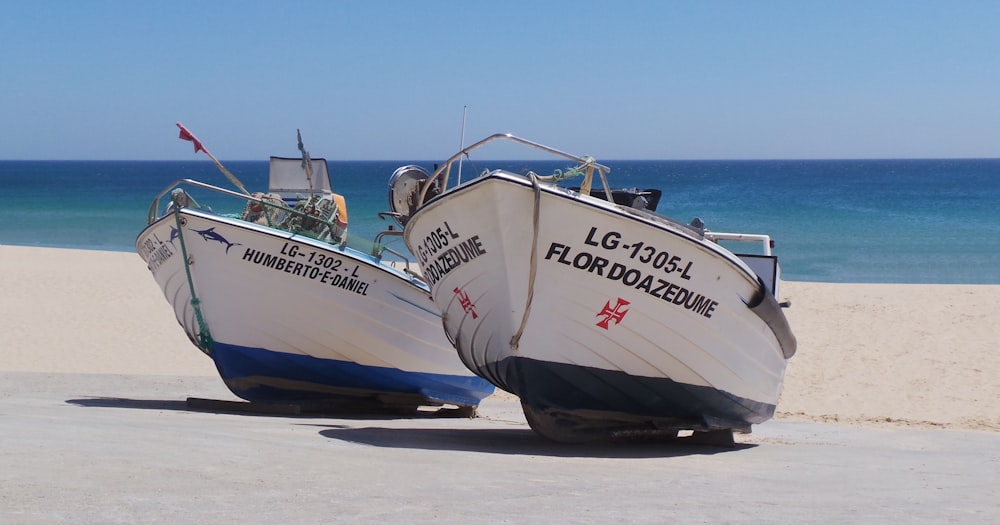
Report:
136,208,493,406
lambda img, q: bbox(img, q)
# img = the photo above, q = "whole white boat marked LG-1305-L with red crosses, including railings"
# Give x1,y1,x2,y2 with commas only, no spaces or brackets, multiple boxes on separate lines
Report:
396,134,796,441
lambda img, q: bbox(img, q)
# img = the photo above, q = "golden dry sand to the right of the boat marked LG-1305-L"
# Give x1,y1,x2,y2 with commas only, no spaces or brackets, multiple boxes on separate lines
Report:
777,282,1000,431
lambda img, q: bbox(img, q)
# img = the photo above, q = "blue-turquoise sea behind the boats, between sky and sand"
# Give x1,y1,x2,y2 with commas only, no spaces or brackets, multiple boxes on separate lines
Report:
0,159,1000,284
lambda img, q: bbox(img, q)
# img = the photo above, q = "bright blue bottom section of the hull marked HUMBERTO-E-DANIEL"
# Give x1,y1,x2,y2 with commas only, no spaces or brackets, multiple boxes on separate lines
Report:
211,342,493,406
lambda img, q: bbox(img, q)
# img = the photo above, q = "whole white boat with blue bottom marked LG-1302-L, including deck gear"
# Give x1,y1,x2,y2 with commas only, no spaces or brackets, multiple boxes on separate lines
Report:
136,128,493,412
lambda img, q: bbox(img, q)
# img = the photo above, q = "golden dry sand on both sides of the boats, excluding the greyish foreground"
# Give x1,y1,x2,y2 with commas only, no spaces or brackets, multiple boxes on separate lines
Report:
0,246,1000,432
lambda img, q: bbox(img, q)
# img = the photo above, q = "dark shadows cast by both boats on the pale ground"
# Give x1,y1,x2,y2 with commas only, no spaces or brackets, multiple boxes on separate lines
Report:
66,397,756,459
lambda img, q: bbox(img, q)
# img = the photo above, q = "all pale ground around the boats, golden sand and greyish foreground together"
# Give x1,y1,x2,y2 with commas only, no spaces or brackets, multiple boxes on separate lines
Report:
0,246,1000,525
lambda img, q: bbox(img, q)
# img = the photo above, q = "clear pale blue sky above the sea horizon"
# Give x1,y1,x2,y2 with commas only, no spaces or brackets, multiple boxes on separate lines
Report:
0,0,1000,160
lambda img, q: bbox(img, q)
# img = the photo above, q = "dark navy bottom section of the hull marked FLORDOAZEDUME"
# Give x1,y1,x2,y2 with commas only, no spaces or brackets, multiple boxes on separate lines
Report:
482,357,775,441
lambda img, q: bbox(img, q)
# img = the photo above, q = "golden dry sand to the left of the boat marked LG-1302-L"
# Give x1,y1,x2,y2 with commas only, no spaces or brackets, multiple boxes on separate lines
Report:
0,246,215,376
